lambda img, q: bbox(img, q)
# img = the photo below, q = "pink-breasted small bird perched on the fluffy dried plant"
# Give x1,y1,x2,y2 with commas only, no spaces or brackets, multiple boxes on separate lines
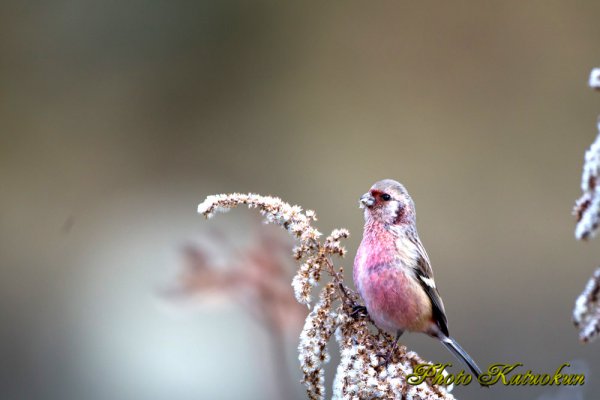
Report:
353,179,481,380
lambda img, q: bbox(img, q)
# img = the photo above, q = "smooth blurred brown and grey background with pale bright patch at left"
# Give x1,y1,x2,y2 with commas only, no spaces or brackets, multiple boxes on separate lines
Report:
0,0,600,400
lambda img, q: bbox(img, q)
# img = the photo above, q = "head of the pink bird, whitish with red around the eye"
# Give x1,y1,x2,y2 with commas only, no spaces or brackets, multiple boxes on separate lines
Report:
359,179,415,225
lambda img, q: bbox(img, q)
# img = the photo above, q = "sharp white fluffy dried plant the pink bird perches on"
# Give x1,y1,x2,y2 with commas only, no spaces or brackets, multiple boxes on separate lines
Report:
198,193,454,400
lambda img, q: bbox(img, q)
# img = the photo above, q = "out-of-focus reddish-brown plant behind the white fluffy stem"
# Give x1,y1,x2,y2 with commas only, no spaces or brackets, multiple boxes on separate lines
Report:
163,222,307,398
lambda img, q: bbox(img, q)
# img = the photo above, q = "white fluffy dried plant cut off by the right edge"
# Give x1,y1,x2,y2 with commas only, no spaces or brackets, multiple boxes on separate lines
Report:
573,68,600,343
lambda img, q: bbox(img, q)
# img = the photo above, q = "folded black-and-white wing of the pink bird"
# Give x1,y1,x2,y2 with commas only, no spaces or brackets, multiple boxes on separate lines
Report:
411,231,449,336
